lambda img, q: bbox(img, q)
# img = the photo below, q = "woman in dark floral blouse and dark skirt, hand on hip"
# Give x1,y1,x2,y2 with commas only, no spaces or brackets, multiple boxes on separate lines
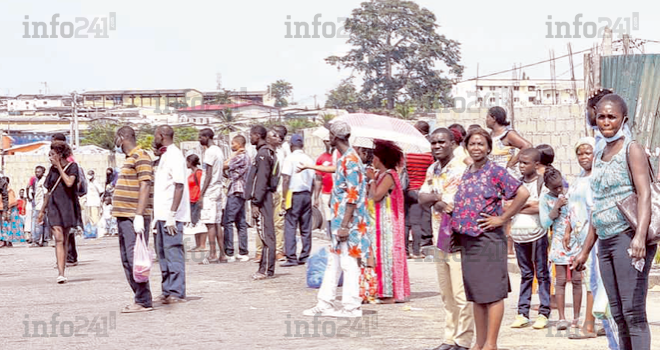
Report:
452,129,529,350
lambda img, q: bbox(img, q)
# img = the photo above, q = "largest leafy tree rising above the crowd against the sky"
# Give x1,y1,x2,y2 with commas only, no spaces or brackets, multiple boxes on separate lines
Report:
326,0,463,110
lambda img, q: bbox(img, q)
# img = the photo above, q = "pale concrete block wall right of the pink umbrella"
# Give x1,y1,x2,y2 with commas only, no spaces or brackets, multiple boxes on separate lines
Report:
436,104,586,182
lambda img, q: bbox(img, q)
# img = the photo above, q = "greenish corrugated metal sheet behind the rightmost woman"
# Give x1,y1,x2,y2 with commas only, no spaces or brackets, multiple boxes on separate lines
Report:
601,55,660,169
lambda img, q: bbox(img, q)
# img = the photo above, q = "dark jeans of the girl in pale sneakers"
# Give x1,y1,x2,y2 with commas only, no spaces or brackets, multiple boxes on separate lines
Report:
514,234,550,318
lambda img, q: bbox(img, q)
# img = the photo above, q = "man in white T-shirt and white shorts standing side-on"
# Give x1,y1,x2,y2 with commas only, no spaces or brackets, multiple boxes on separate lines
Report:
197,128,227,265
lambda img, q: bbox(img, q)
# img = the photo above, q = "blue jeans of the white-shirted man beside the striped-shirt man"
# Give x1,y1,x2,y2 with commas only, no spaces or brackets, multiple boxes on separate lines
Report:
156,220,186,299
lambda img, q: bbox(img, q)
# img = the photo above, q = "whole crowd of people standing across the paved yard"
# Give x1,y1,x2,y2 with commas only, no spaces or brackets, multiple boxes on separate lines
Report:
0,90,656,350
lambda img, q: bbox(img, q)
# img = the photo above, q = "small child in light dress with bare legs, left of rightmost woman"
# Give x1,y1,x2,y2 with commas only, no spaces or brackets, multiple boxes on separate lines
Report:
539,167,582,330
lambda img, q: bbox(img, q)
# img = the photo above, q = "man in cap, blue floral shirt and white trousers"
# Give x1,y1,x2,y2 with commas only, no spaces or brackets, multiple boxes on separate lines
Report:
303,120,371,317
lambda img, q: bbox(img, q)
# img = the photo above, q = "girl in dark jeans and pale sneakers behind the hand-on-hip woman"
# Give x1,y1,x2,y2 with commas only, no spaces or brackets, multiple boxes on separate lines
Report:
511,148,550,329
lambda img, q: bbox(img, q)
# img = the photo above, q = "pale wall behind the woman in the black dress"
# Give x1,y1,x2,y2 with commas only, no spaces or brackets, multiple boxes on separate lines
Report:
4,152,124,191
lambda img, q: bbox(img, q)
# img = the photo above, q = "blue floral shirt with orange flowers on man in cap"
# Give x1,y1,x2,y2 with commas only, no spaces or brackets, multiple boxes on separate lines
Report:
330,147,371,261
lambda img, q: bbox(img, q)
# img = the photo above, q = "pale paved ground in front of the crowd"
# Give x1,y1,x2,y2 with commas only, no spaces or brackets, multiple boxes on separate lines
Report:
0,232,660,350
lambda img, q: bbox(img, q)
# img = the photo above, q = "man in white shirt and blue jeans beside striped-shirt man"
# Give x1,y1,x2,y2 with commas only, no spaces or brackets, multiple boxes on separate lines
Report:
154,125,190,304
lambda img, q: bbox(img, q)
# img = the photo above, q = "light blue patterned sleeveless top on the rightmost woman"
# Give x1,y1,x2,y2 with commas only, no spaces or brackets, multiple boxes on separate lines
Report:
591,137,634,239
